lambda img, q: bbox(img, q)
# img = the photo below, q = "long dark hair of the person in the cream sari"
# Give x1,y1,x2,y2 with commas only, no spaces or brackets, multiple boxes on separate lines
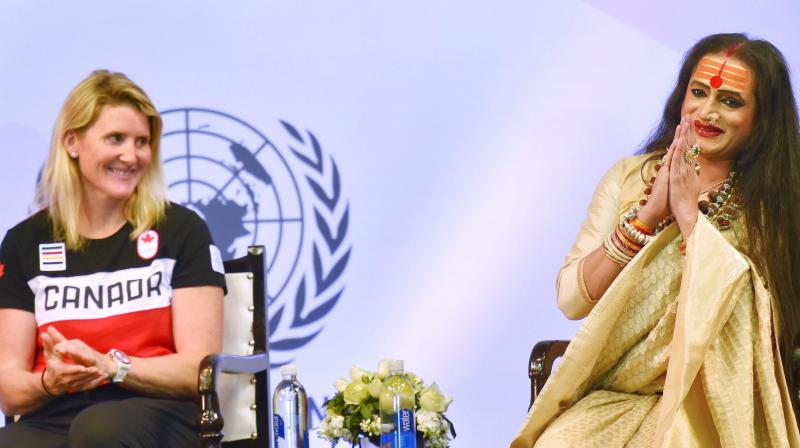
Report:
640,34,800,413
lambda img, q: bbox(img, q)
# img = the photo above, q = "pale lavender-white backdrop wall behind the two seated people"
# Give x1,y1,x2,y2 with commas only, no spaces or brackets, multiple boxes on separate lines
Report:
0,0,800,447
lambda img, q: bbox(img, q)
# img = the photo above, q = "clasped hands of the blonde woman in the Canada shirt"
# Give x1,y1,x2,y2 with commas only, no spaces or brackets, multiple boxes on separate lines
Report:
41,327,116,395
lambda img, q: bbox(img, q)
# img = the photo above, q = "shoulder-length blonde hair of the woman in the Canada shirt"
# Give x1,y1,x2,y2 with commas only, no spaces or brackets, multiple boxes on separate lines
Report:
37,70,168,250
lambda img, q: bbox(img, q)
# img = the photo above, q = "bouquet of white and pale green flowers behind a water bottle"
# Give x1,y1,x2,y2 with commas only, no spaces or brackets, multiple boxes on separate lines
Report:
317,360,456,448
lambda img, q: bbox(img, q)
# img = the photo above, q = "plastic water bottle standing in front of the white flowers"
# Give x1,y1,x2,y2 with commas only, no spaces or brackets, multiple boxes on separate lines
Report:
379,360,417,448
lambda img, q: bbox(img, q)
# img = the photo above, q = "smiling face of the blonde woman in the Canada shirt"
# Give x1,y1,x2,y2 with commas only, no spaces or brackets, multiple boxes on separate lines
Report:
64,105,152,207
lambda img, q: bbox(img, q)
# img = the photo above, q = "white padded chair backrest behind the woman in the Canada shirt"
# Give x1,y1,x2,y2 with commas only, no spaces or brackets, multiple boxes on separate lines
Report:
217,246,269,446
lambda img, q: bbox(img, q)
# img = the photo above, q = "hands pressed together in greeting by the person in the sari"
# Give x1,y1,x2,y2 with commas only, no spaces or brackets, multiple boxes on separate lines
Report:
639,116,700,240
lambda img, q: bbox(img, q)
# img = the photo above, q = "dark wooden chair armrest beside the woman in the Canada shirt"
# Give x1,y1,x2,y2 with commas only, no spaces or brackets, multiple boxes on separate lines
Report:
197,352,269,448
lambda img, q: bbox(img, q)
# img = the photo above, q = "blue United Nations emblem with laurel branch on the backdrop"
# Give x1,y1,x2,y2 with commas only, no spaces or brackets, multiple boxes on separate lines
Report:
161,108,350,366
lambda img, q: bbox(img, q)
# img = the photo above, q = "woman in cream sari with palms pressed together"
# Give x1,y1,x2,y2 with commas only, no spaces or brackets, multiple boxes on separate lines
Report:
511,34,800,448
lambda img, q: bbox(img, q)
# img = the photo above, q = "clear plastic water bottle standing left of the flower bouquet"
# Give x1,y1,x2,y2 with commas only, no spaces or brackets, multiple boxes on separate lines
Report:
272,365,308,448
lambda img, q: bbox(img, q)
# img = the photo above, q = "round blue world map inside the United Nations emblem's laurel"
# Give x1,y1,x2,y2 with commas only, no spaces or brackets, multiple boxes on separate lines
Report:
161,108,305,303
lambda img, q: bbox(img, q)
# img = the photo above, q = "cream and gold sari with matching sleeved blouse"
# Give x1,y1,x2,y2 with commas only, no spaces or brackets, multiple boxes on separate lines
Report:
511,156,800,448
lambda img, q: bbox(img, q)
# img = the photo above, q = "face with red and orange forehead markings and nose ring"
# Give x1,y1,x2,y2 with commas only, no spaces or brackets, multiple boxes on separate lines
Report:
681,51,756,160
